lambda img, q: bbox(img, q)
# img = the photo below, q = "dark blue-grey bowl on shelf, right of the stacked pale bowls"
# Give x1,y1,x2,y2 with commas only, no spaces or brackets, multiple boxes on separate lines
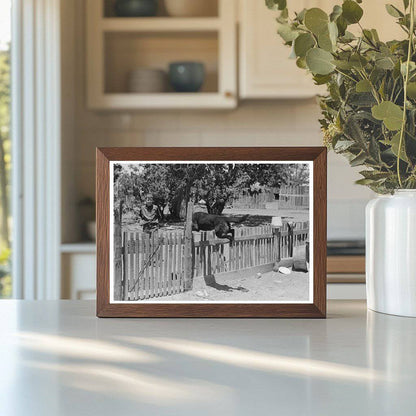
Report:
169,62,205,92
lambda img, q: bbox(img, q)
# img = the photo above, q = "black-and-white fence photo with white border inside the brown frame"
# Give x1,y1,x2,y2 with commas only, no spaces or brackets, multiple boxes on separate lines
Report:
110,161,313,303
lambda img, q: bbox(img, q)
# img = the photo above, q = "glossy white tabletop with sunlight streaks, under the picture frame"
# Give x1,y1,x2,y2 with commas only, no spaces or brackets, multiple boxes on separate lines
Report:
0,301,416,416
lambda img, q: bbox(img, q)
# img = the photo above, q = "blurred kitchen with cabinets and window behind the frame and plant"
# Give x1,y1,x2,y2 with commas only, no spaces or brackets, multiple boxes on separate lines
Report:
0,0,399,299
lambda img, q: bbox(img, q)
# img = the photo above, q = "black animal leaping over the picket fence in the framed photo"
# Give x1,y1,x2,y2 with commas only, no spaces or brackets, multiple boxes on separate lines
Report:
192,212,248,243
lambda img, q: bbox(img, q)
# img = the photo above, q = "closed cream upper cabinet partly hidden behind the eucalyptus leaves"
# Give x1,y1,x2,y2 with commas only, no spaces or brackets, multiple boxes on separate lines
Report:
239,0,404,99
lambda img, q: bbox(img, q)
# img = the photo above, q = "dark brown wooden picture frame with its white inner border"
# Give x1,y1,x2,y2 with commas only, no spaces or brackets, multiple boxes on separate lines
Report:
96,147,327,318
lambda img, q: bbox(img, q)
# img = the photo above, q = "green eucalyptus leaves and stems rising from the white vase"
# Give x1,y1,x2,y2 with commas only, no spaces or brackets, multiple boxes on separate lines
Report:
266,0,416,194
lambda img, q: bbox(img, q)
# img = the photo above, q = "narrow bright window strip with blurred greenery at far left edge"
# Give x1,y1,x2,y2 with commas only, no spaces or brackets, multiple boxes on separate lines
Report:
0,0,12,298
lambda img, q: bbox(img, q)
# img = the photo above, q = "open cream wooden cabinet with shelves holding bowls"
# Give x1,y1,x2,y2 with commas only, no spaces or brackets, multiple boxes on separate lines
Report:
86,0,237,110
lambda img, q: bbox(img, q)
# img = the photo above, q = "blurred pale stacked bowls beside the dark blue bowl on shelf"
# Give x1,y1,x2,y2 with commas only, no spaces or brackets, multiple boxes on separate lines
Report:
127,68,167,93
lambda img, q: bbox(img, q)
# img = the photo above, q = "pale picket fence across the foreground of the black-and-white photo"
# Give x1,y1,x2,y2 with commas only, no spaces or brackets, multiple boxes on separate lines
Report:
122,222,309,300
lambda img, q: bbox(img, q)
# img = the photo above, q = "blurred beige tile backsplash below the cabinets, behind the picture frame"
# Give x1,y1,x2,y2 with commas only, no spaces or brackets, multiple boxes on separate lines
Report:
71,100,372,238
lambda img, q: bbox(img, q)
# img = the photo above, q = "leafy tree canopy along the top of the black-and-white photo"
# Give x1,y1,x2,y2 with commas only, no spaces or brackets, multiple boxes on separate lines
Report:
114,163,309,219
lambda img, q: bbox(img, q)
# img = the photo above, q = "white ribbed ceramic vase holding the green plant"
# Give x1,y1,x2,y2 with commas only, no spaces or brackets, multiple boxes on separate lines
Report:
366,190,416,317
